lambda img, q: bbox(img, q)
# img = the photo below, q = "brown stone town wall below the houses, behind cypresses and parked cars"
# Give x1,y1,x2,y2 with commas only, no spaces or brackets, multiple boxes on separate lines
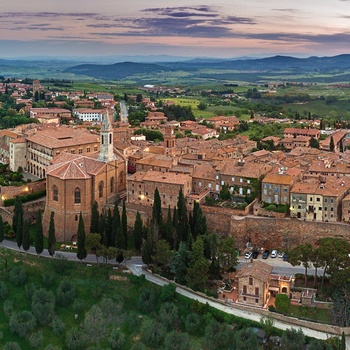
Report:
120,204,350,250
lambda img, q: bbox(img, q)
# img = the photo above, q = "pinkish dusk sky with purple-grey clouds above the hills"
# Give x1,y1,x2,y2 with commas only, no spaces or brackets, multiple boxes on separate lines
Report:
0,0,350,57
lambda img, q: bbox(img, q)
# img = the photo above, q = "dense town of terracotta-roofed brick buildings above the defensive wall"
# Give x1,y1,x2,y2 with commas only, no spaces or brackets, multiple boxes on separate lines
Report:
0,80,350,241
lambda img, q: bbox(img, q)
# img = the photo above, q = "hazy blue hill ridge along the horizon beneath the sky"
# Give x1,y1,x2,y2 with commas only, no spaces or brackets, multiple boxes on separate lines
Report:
65,54,350,80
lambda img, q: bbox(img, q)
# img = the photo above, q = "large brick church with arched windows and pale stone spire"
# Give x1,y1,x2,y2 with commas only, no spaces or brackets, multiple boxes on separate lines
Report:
43,113,126,242
